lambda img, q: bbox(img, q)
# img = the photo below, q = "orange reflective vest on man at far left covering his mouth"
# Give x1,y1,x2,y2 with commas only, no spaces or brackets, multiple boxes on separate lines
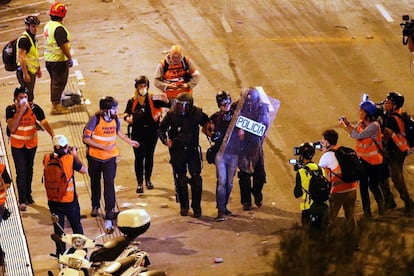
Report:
10,106,38,149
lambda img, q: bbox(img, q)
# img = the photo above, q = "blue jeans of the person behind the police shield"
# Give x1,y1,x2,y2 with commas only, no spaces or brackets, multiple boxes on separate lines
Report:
215,154,238,212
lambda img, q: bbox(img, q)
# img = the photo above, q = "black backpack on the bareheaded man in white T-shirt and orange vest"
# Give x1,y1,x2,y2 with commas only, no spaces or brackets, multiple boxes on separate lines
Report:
334,147,365,183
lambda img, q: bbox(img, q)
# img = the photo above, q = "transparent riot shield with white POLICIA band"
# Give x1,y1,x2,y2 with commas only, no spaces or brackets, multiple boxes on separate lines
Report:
217,87,280,172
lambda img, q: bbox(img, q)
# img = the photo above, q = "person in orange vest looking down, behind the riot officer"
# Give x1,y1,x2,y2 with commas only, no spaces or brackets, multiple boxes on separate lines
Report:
154,45,200,100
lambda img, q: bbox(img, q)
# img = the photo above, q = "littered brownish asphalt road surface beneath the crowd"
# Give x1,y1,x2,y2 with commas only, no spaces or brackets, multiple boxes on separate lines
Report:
0,0,414,275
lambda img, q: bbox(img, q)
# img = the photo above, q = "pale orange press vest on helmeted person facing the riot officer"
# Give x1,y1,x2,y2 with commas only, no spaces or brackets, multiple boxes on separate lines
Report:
86,116,119,160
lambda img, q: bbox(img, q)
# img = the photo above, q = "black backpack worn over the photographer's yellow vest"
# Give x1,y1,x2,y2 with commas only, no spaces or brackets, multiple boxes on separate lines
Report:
305,166,331,203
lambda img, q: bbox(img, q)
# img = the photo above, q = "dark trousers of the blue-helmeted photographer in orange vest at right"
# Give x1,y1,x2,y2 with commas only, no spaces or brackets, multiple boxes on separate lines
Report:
359,159,385,216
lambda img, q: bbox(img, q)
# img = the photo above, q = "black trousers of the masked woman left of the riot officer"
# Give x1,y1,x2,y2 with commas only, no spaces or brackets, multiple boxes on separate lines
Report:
133,133,158,184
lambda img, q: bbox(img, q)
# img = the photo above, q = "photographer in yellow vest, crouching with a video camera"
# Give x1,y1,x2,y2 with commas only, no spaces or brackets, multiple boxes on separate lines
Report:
293,143,328,235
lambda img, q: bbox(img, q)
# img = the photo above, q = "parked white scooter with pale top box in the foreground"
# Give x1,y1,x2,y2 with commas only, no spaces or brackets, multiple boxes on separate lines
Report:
49,209,166,276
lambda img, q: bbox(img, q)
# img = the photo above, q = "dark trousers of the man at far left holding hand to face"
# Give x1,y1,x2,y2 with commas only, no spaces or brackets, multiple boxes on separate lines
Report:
11,147,37,204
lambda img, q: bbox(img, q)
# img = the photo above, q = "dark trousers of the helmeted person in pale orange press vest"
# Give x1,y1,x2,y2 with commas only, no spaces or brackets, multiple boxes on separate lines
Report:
87,155,116,219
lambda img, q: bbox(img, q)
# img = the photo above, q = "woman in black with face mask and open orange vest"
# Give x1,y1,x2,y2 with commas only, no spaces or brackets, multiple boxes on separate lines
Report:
124,76,171,194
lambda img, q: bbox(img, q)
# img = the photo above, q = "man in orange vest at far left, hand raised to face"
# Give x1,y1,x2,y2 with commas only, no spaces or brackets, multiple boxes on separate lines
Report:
6,87,54,211
